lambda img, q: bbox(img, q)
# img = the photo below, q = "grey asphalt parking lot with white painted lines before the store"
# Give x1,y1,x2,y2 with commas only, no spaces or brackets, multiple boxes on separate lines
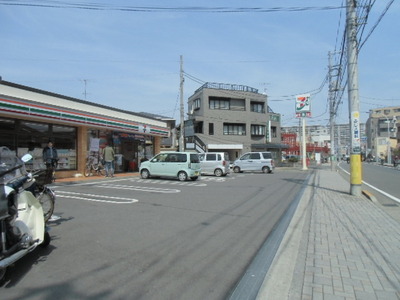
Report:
0,170,308,300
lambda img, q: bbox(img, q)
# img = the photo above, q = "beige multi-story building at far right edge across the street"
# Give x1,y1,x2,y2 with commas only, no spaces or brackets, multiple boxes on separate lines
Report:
366,106,400,161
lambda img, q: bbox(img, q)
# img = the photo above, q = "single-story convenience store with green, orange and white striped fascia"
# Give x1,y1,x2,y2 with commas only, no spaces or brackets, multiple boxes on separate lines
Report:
0,80,172,178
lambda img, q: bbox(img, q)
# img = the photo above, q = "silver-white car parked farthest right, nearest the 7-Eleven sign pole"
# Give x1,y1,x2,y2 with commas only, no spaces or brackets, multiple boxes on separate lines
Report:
233,152,275,173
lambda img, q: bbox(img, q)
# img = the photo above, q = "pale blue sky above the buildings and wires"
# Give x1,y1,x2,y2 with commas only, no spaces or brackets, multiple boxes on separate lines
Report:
0,0,400,126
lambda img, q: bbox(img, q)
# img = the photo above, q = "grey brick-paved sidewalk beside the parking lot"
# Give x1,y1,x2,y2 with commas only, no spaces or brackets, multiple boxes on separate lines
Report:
258,169,400,300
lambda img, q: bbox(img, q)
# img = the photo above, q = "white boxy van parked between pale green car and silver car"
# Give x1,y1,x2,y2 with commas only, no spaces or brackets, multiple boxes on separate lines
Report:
199,152,230,177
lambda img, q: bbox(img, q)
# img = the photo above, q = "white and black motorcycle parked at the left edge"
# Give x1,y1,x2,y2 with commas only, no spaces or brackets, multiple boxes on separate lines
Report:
0,147,50,280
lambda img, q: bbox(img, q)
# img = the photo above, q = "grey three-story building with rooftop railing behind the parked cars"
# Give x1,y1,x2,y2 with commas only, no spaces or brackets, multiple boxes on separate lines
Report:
185,83,285,160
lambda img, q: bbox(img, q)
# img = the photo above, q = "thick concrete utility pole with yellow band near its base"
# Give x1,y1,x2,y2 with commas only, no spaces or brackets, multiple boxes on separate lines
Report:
346,0,362,196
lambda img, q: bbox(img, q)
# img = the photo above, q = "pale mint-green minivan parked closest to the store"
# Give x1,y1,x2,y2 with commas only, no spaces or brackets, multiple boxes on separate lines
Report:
139,152,201,181
